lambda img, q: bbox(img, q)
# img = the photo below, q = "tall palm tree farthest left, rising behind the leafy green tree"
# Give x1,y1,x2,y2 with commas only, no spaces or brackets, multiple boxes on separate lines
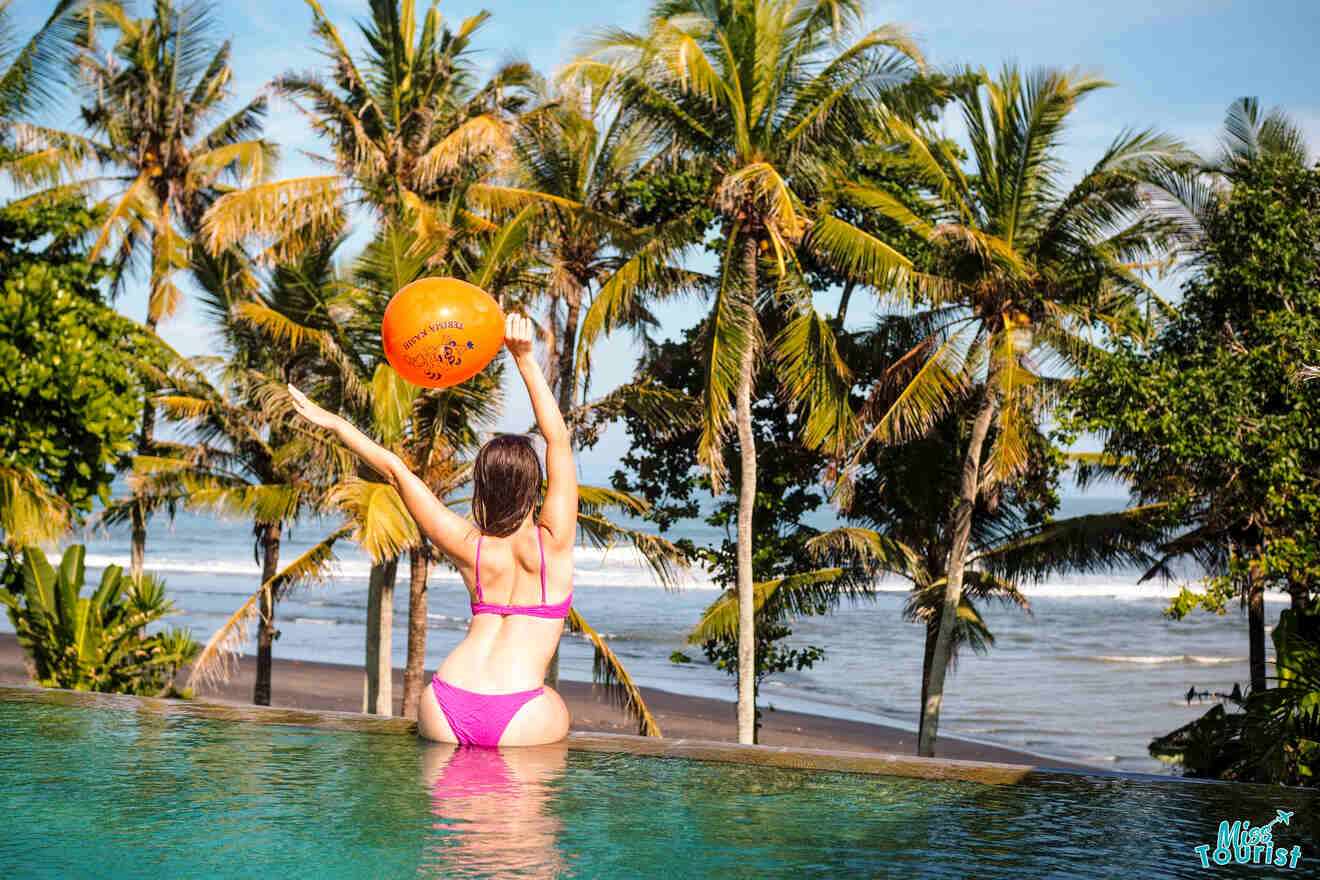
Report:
5,0,276,577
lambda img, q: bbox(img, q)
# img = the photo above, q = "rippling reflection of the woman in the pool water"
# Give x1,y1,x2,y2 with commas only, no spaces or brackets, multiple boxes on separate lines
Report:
420,743,568,877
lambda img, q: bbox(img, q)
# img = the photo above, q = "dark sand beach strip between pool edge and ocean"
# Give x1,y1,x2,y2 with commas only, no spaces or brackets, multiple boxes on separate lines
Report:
0,633,1115,772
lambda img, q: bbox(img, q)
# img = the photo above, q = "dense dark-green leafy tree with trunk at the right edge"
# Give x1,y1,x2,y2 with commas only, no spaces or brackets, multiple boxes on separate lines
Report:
1064,99,1320,691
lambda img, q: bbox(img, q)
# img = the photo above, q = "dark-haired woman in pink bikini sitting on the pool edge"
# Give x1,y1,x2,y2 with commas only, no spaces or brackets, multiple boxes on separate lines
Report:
289,315,578,745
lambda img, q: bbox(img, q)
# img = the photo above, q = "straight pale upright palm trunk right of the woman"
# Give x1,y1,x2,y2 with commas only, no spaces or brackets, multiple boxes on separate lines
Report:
737,235,756,743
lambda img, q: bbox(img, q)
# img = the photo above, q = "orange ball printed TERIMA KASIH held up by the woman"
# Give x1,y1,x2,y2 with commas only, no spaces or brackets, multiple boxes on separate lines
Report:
380,278,504,388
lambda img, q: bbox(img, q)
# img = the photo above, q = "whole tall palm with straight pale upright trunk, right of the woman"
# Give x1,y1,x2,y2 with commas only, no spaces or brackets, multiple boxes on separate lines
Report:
569,0,920,743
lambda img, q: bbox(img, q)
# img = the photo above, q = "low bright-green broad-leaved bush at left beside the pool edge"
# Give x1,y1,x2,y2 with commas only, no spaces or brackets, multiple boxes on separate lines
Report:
0,545,202,697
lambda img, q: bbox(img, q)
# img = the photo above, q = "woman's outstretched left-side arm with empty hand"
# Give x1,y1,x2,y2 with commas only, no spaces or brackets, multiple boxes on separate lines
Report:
289,385,477,565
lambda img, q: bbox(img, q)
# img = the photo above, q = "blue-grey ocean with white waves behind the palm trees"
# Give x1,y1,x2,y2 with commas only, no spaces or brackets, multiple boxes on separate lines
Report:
0,499,1287,772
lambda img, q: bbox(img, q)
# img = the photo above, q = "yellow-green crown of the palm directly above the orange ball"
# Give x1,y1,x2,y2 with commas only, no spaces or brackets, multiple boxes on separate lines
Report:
205,0,529,263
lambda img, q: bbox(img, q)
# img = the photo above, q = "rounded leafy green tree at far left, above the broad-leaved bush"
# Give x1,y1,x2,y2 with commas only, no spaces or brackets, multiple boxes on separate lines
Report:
0,198,144,551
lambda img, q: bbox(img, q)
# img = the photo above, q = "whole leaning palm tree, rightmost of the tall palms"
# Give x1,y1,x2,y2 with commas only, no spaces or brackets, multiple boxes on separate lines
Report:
842,67,1187,756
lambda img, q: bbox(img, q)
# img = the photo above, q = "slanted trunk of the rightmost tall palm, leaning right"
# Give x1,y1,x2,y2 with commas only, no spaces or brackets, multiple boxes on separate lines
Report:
916,379,995,757
